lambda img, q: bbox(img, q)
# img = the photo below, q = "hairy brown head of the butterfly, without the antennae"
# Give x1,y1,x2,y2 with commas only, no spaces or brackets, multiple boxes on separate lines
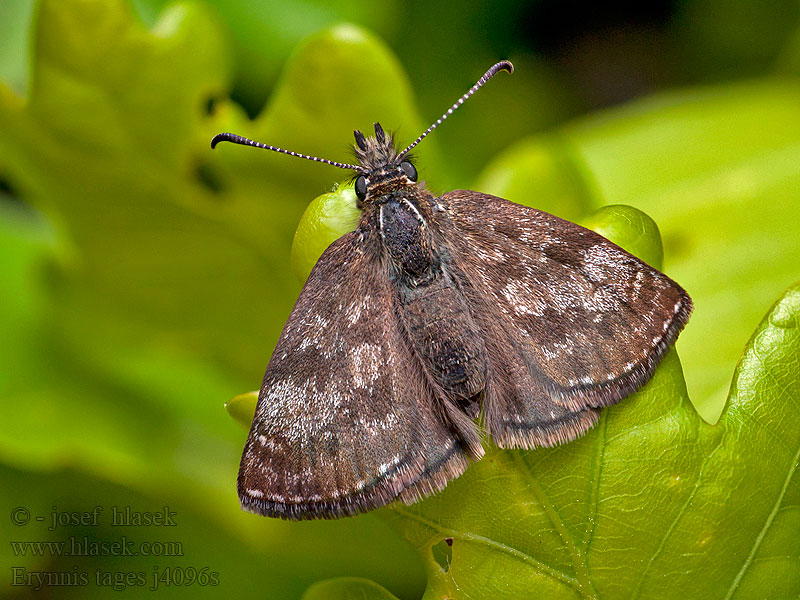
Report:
354,123,417,205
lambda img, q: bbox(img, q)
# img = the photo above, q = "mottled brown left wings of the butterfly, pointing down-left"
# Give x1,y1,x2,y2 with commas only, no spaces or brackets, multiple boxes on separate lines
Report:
238,232,468,518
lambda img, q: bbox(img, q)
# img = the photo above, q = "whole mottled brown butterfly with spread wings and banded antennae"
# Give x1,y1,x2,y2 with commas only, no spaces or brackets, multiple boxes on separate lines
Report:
211,61,692,519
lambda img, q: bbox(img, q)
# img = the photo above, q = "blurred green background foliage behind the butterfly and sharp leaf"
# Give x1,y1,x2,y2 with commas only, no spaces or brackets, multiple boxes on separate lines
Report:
0,0,800,599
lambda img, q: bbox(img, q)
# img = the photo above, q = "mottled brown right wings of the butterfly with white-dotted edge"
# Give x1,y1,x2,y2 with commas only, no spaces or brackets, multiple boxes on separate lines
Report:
438,191,692,447
